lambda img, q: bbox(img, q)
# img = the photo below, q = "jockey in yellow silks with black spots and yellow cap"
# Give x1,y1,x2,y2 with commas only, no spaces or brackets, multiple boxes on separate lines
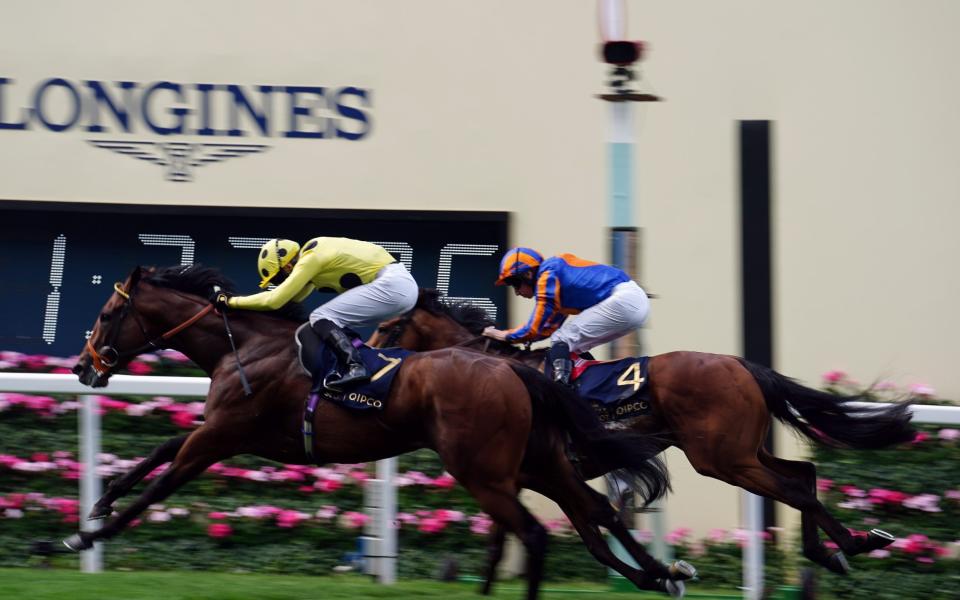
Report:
225,237,419,387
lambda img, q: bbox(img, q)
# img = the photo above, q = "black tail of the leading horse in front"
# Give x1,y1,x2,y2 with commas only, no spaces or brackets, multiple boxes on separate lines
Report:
510,362,670,506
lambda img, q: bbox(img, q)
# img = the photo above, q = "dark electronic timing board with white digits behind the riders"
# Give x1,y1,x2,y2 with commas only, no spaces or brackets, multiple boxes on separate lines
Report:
0,201,507,356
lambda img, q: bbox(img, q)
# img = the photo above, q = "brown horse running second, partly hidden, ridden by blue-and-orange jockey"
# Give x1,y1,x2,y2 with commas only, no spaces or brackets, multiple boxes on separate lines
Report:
368,290,914,577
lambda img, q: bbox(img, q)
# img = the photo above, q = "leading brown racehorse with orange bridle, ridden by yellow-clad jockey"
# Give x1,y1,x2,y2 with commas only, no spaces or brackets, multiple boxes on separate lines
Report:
71,266,690,598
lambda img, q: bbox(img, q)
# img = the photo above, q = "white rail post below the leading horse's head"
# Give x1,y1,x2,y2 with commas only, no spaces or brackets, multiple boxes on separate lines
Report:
80,395,103,573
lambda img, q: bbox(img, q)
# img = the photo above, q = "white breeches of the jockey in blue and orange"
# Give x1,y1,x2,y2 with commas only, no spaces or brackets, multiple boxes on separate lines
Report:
550,281,650,352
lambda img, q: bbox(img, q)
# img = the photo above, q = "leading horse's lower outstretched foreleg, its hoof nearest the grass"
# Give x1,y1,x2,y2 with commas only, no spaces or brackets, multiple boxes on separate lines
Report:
63,426,237,551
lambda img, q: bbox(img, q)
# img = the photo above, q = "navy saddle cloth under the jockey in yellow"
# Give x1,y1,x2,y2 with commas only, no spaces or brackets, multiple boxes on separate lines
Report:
297,323,413,410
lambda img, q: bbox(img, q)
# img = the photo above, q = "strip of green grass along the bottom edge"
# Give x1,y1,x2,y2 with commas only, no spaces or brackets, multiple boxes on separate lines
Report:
0,569,680,600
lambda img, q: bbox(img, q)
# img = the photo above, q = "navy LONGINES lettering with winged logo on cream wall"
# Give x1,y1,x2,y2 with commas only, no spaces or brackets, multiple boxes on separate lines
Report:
0,77,372,181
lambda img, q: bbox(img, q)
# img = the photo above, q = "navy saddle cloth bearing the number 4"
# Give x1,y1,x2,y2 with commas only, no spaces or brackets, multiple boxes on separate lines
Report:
571,356,650,421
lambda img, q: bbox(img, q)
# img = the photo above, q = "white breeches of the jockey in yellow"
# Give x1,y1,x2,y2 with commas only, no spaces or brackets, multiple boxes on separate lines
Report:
310,263,420,327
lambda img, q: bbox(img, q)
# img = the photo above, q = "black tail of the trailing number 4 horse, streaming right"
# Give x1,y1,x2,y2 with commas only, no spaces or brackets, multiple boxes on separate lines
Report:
739,359,915,450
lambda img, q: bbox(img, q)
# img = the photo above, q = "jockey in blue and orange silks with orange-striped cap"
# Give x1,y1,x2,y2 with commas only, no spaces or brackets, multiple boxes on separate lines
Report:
483,247,650,385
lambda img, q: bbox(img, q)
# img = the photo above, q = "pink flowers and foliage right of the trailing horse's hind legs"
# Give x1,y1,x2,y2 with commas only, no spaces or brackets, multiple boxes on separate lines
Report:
812,371,960,600
